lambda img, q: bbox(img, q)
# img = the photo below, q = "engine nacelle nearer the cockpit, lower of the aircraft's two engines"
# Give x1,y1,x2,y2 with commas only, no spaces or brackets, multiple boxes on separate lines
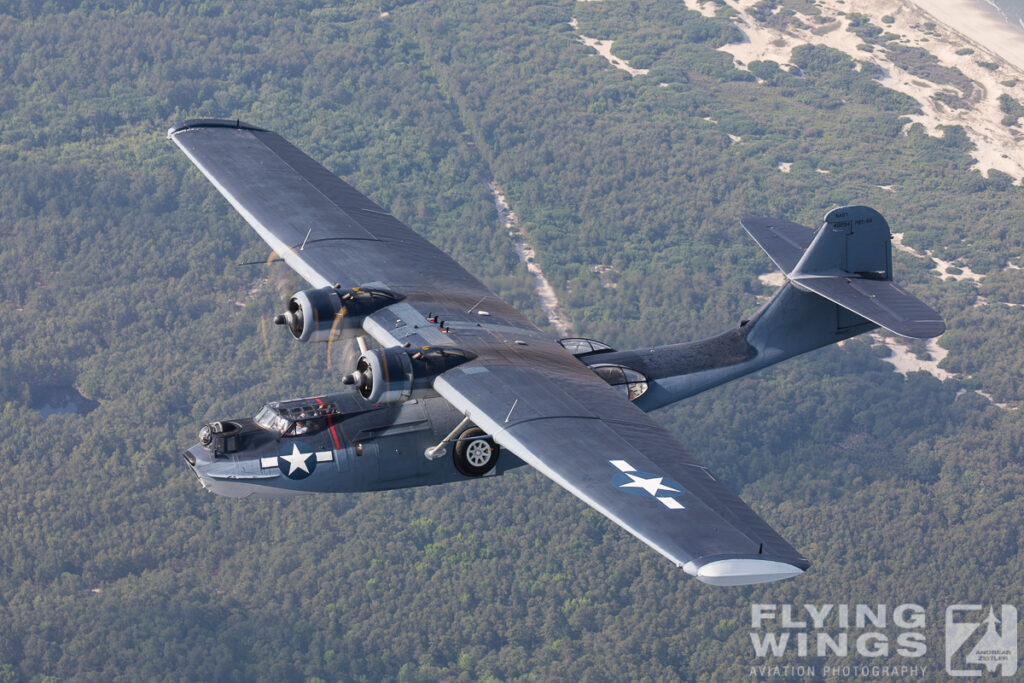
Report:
341,347,475,403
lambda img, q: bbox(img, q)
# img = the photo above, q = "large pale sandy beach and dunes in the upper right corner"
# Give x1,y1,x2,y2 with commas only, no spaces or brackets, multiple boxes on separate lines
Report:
686,0,1024,184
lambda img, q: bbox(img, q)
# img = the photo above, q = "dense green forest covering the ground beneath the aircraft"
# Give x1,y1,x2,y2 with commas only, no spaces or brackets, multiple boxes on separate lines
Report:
0,0,1024,683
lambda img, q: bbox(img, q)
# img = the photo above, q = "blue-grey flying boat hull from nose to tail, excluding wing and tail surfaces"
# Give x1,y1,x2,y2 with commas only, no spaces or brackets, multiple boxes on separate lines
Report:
184,285,874,498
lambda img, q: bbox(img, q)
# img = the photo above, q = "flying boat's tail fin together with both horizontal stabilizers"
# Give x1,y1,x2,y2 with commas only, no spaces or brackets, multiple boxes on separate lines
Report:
740,206,946,339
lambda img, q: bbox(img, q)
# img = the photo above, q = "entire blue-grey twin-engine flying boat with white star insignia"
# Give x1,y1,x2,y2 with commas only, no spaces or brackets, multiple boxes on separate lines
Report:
168,120,945,586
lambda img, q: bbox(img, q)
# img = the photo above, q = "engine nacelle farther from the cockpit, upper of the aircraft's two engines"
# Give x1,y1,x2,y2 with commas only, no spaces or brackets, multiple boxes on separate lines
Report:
273,287,401,342
